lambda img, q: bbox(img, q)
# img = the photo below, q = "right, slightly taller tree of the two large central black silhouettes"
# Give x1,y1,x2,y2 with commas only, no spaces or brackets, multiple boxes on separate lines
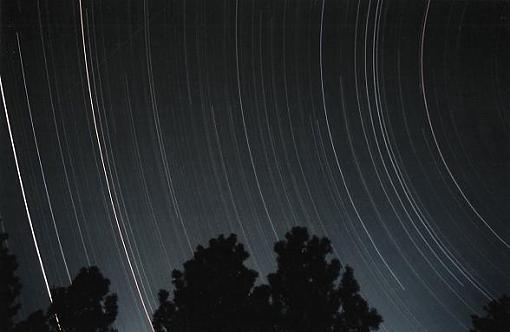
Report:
268,227,382,332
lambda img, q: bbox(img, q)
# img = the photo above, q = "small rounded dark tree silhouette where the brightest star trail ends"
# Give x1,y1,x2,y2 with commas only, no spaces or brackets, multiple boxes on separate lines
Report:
48,266,117,332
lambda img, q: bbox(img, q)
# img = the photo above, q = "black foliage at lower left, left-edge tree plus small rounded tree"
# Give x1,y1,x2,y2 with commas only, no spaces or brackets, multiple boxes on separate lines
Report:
0,227,117,332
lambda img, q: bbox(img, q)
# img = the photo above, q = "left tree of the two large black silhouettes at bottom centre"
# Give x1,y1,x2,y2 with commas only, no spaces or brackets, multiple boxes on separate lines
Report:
153,234,257,332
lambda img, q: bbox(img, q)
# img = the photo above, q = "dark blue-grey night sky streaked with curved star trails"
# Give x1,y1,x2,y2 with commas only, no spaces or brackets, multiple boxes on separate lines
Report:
0,0,510,332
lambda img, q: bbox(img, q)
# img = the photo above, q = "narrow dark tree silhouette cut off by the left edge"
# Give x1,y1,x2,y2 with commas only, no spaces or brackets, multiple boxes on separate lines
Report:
0,233,21,331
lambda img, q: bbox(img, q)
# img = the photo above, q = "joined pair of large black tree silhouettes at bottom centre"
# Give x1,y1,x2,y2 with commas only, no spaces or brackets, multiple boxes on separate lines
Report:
153,227,382,332
